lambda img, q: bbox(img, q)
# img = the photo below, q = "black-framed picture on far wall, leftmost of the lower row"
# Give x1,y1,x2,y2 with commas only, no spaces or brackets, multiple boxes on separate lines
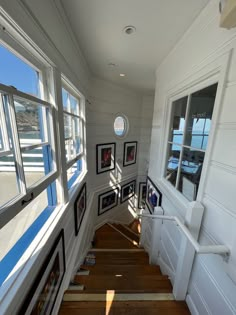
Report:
98,188,119,215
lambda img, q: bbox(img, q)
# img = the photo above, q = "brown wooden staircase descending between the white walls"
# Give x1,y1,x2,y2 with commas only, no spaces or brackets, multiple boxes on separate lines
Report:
59,222,190,315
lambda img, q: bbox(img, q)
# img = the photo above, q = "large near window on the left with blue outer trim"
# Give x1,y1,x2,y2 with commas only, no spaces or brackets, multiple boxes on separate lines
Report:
0,34,58,270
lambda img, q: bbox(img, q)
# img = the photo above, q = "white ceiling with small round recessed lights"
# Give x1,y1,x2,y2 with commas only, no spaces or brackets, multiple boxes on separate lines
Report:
60,0,209,91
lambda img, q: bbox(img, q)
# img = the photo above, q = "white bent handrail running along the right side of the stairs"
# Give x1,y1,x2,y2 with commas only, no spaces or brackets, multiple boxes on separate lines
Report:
138,214,230,256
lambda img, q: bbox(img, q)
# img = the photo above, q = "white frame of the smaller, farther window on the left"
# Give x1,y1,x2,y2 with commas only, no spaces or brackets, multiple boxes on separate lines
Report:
61,75,87,189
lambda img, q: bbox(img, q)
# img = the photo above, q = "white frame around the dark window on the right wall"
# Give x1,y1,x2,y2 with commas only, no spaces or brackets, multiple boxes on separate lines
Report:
159,51,231,205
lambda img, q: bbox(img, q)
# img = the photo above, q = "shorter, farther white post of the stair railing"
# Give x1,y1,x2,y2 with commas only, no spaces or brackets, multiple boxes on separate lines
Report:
149,207,164,265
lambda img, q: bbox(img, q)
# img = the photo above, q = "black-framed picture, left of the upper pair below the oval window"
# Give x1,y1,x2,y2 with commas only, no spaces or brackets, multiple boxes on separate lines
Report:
96,143,116,174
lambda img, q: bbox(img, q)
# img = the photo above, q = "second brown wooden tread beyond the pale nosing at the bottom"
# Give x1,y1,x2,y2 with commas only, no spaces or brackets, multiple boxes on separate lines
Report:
81,264,161,275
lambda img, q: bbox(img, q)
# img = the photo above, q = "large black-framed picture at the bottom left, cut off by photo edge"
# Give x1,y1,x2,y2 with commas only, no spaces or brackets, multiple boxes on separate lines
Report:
18,230,65,315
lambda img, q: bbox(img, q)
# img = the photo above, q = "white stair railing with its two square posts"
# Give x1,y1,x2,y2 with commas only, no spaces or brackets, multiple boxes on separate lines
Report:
139,205,231,300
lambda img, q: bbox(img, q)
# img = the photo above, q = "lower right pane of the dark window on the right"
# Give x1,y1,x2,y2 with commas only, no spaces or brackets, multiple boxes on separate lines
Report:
178,148,205,201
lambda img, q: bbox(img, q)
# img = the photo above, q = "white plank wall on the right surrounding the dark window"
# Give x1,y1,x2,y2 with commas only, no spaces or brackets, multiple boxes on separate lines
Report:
149,1,236,315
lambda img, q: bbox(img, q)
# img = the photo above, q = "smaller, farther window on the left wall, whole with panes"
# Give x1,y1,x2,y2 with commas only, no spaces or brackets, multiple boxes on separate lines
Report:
62,80,85,189
